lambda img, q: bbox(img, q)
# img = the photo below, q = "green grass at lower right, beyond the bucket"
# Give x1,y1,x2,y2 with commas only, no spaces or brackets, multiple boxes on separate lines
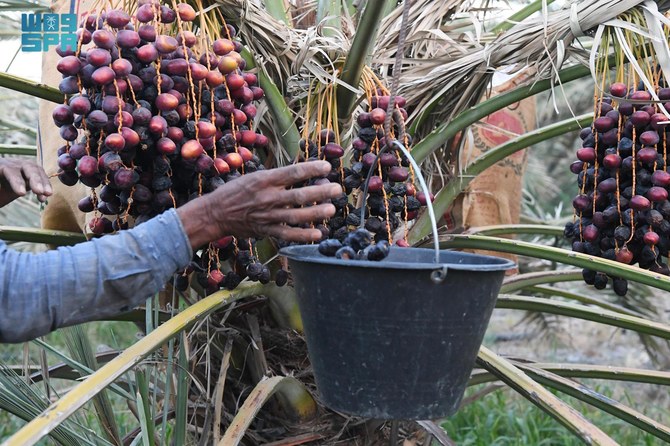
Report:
442,386,670,446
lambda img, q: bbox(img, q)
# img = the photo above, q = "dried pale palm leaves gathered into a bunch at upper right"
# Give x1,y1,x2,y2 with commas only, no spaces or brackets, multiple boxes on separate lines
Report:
375,0,668,138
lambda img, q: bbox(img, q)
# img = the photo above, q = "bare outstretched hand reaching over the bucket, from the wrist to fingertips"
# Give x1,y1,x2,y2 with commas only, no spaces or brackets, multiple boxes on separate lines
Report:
177,161,342,249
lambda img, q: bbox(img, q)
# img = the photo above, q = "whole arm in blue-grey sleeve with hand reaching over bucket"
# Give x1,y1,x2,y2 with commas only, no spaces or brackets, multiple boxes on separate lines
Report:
0,162,342,342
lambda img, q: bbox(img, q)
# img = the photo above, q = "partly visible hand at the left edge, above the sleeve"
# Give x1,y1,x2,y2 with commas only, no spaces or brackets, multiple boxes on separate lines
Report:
0,158,53,207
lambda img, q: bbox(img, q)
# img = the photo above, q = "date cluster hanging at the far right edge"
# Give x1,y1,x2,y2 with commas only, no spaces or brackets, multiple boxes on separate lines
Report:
565,83,670,296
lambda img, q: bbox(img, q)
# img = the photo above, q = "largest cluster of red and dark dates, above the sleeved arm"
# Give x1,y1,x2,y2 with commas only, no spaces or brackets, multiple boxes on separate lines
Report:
53,0,286,290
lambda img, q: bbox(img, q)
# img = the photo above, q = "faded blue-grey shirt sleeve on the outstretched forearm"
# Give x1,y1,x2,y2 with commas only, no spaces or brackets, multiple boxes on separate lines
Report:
0,209,192,342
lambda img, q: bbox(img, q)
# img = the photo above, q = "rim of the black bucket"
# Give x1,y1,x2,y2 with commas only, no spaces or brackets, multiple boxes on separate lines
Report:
279,245,517,271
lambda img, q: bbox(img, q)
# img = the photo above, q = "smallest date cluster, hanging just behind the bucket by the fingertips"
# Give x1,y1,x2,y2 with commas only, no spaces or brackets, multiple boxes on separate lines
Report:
301,91,426,257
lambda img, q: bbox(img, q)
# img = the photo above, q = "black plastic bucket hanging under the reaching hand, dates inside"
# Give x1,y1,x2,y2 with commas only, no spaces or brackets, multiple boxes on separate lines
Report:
280,245,514,420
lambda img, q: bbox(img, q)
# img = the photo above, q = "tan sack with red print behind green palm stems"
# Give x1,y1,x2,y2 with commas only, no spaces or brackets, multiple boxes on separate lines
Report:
445,72,537,268
